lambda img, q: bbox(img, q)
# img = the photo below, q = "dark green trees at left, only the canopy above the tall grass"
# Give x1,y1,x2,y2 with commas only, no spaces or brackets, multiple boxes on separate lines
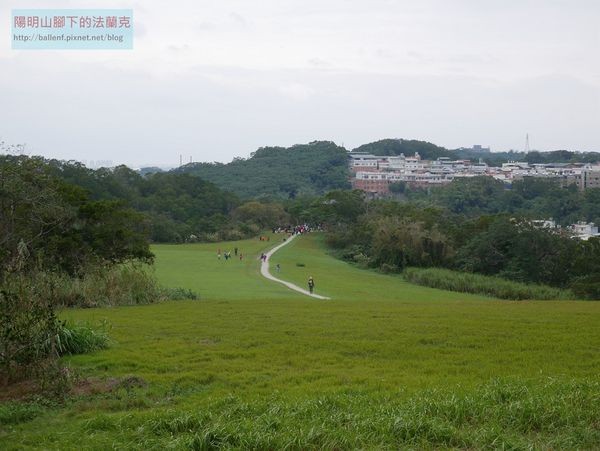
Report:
0,156,152,277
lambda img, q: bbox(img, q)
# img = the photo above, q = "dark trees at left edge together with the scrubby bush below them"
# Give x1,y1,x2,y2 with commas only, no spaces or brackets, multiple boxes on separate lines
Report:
0,155,153,383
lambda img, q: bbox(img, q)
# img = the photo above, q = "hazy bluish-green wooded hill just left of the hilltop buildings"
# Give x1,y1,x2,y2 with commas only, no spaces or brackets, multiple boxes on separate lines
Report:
175,141,350,199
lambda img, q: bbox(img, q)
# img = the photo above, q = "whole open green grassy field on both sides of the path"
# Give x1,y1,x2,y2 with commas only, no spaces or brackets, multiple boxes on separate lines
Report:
0,235,600,449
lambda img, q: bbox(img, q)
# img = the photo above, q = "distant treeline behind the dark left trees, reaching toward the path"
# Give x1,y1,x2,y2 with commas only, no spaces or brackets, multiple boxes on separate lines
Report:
1,155,298,245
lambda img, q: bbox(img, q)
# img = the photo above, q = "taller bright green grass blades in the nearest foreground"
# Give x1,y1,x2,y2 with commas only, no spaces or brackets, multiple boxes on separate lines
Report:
138,379,600,450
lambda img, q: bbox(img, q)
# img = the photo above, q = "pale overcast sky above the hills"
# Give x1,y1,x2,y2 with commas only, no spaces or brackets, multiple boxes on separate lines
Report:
0,0,600,166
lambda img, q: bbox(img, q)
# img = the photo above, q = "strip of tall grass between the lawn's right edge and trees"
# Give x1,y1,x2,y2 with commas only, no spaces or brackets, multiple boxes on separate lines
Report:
402,268,575,300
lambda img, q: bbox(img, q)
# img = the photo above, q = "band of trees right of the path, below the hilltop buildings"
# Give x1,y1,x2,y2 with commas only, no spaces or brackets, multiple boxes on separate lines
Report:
290,191,600,299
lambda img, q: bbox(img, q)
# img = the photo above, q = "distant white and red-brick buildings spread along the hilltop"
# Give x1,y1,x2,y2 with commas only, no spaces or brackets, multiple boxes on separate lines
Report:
349,153,600,195
